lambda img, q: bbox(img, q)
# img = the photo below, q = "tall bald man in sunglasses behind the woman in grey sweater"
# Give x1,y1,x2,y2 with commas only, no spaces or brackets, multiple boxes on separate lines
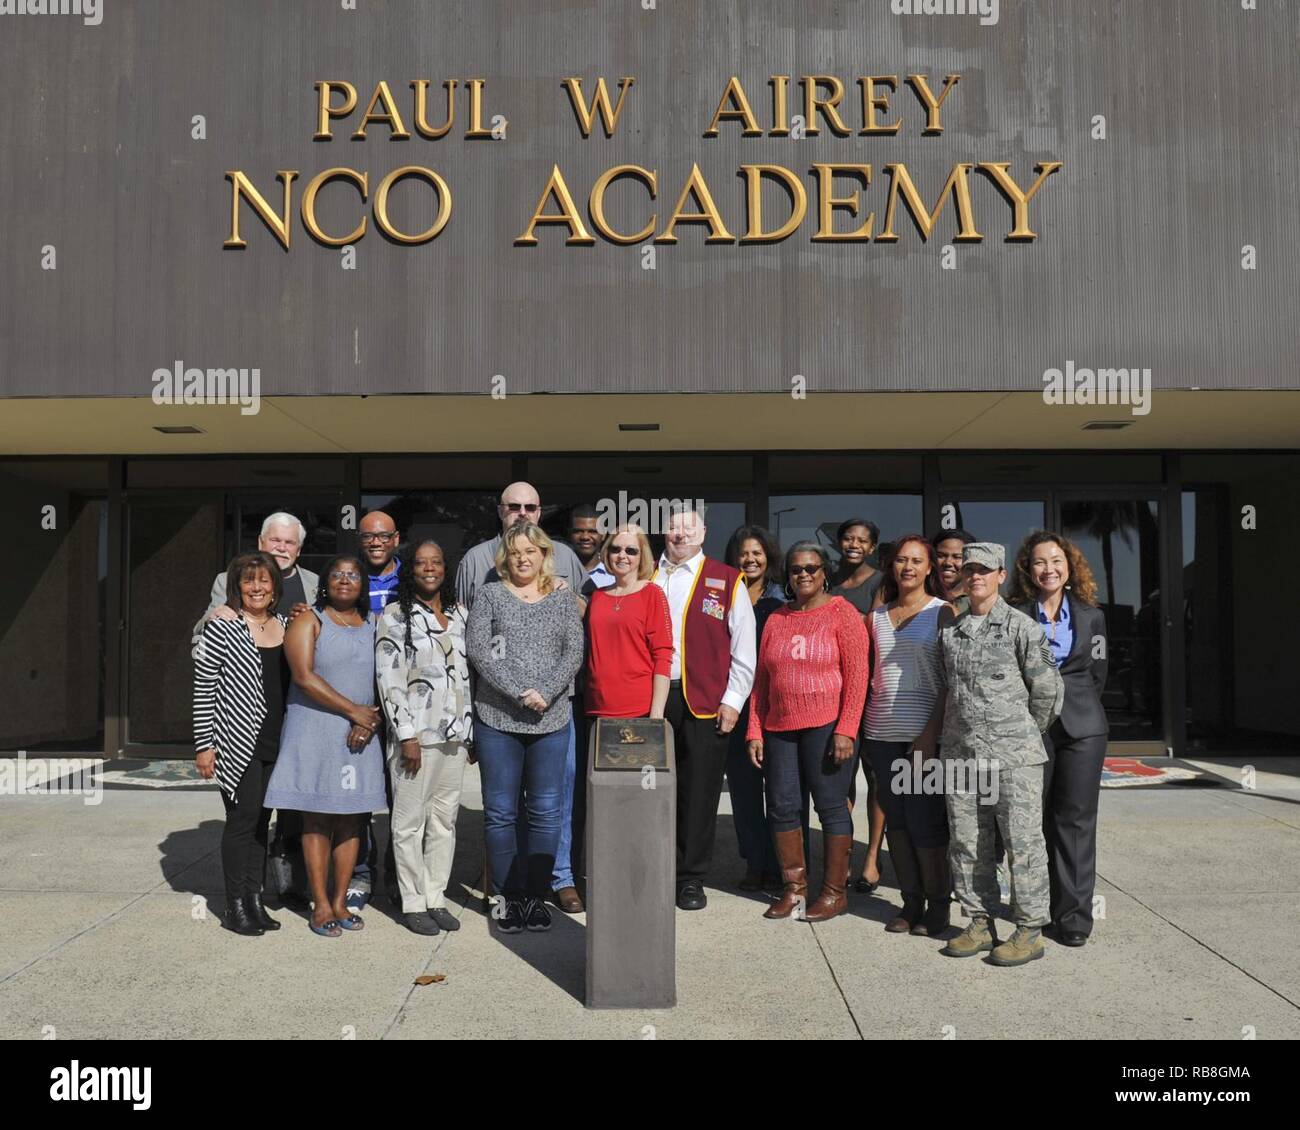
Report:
456,482,586,914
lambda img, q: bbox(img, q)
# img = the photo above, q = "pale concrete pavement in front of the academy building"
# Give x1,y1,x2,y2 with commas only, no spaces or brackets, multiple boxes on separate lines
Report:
0,758,1300,1040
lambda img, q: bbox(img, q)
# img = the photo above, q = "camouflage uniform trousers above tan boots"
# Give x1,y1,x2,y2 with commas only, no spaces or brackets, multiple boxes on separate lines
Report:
944,765,1052,926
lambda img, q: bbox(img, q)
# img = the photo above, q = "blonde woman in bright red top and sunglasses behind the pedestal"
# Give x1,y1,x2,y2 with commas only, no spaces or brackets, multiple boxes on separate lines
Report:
585,525,672,718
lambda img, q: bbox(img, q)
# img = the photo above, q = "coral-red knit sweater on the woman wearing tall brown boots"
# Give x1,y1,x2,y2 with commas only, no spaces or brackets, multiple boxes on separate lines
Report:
748,597,871,739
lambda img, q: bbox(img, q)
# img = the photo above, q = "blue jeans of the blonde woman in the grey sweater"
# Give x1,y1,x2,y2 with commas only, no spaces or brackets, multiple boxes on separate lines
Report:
475,719,572,899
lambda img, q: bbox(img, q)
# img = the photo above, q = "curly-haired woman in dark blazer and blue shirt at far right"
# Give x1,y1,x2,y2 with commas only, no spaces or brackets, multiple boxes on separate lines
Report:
1013,529,1109,945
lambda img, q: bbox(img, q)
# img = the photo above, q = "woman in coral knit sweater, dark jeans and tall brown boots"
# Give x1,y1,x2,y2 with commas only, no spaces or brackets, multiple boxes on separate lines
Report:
748,541,871,922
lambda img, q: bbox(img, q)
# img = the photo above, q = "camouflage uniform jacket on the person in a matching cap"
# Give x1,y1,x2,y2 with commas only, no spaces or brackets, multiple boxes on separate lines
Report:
939,597,1065,769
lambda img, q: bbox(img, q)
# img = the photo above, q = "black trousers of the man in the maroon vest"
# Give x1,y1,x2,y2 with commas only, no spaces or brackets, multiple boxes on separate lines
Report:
664,683,731,883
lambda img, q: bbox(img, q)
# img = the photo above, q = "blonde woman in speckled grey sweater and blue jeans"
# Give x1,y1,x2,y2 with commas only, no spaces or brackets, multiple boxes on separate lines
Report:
465,523,582,934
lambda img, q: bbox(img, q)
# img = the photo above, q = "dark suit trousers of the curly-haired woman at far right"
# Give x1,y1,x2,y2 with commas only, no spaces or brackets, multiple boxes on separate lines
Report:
1043,722,1106,934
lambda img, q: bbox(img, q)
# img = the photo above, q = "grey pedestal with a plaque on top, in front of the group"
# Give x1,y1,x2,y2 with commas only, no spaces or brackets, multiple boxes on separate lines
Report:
585,718,677,1008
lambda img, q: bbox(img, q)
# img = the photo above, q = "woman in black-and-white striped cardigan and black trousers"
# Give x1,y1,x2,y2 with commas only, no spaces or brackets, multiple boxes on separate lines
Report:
194,553,289,936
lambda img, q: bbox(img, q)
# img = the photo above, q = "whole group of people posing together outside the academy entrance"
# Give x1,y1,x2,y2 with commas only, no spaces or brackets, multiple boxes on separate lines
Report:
194,482,1106,965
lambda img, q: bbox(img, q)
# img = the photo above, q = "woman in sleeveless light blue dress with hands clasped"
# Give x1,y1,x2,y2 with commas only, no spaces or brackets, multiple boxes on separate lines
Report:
265,557,387,938
